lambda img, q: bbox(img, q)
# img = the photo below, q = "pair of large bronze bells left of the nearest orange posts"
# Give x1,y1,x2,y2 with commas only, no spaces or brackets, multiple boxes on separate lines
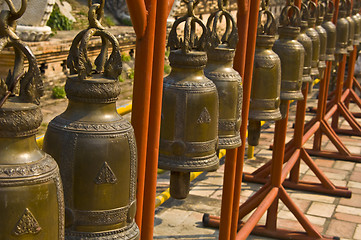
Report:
0,1,139,240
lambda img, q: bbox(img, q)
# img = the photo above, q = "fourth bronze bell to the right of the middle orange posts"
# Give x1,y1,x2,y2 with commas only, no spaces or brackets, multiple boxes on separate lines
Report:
306,1,320,78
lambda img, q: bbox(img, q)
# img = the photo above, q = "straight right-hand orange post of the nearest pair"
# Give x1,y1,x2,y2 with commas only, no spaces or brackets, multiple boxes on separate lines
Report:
141,0,173,240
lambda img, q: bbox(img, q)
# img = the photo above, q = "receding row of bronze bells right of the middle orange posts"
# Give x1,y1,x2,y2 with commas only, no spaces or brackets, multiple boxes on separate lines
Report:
248,0,361,146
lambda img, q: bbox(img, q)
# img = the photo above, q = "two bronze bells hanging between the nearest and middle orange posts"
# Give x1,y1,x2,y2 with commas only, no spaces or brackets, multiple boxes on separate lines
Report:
159,0,243,199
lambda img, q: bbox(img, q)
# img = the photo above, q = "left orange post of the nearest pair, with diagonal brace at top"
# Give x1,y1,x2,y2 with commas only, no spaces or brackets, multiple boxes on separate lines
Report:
127,0,156,229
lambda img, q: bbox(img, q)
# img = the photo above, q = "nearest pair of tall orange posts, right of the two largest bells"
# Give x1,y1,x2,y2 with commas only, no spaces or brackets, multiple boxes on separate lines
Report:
127,0,174,240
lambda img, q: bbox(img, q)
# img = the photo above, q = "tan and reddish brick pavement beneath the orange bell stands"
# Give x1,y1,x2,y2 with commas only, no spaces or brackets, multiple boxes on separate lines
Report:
154,83,361,240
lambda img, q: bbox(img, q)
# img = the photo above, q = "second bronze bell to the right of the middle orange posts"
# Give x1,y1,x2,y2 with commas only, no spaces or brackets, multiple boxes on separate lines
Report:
273,1,305,117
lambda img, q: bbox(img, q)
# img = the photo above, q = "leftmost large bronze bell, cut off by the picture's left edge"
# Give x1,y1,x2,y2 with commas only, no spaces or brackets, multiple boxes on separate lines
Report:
0,1,64,236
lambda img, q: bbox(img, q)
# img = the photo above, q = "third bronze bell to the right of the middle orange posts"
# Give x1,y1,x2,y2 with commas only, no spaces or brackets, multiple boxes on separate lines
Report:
297,3,312,82
